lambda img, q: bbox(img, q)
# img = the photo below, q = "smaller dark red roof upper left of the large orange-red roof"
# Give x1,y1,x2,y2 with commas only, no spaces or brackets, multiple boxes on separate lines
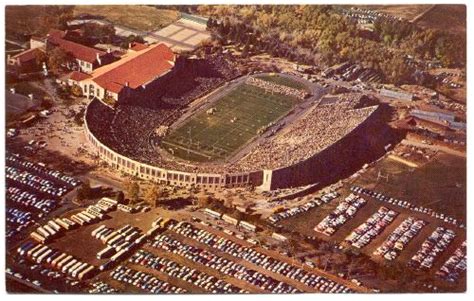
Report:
48,30,106,64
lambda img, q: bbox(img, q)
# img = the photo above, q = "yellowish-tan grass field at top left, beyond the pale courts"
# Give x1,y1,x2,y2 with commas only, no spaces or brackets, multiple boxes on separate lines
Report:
74,5,179,31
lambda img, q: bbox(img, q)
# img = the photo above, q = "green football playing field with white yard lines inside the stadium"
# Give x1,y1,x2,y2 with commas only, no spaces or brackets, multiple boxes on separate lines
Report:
163,84,297,162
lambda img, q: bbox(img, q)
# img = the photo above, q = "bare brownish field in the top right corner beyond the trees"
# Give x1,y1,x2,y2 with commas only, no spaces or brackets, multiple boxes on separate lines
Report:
416,4,466,34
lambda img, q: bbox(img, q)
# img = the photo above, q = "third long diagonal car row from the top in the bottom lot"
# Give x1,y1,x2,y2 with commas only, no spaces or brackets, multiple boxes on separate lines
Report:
129,249,245,294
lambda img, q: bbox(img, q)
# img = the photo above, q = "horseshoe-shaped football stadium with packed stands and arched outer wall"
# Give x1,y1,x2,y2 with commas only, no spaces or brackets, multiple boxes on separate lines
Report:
84,50,389,190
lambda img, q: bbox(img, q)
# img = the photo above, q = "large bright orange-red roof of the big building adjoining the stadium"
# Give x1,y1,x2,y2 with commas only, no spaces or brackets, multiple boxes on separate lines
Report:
94,44,175,93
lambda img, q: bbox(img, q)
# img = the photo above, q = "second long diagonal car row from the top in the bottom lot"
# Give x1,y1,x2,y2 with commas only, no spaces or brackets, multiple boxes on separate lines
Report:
152,234,292,293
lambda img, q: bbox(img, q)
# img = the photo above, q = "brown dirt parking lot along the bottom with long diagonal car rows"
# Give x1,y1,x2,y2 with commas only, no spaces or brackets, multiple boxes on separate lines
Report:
10,190,370,293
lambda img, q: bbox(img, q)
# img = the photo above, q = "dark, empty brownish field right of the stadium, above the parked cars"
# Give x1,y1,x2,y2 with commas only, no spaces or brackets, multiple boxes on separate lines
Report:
355,154,466,220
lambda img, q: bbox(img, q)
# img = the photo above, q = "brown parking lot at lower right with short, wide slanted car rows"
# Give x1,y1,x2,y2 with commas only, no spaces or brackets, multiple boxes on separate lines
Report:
277,187,466,286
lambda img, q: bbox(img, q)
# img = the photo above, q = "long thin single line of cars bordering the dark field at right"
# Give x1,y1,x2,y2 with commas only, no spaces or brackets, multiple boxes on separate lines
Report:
351,186,465,228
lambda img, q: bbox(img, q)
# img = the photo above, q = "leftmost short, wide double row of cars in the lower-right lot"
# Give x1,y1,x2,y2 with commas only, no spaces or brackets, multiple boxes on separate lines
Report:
314,193,367,236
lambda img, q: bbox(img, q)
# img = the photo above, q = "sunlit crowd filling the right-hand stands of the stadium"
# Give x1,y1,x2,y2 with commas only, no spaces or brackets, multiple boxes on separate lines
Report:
235,98,376,171
